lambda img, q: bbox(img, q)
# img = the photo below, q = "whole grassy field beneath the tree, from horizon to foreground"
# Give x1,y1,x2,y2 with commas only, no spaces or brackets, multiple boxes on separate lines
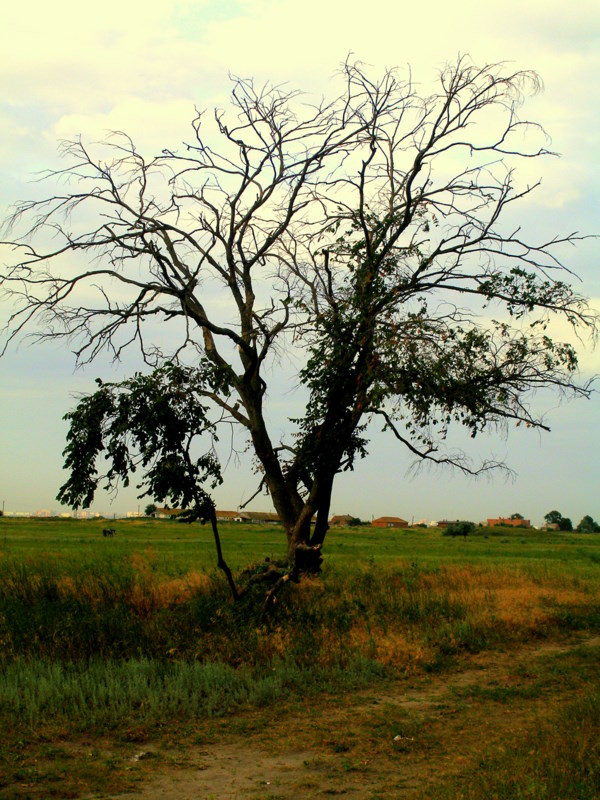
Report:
0,518,600,800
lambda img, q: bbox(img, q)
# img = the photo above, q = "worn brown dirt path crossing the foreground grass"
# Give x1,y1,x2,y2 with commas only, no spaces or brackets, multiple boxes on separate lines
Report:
94,637,600,800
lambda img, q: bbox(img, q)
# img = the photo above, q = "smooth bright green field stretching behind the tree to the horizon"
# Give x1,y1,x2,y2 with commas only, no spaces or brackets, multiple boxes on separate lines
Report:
0,517,600,577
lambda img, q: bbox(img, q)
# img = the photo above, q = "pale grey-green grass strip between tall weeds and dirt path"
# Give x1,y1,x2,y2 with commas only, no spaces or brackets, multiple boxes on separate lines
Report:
0,659,383,733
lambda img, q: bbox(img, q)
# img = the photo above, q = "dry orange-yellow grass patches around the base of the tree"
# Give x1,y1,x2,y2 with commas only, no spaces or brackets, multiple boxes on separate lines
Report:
18,548,599,673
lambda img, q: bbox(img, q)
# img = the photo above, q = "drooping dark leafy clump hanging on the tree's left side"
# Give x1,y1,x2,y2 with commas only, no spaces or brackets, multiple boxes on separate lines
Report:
57,364,222,518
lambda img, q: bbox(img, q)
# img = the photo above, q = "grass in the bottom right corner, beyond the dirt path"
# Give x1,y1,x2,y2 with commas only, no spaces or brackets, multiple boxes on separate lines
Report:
413,647,600,800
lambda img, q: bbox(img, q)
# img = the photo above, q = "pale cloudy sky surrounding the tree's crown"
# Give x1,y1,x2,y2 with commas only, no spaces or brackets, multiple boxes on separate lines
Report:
0,0,600,524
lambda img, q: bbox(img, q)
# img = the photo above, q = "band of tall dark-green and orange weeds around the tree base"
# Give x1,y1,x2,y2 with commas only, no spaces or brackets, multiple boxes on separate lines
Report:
0,551,600,670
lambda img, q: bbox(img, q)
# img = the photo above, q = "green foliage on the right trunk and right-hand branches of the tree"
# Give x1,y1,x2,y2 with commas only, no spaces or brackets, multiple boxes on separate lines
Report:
299,233,577,482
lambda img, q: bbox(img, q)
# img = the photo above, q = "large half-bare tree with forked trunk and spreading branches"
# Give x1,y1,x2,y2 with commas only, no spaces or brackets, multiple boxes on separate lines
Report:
2,58,596,592
